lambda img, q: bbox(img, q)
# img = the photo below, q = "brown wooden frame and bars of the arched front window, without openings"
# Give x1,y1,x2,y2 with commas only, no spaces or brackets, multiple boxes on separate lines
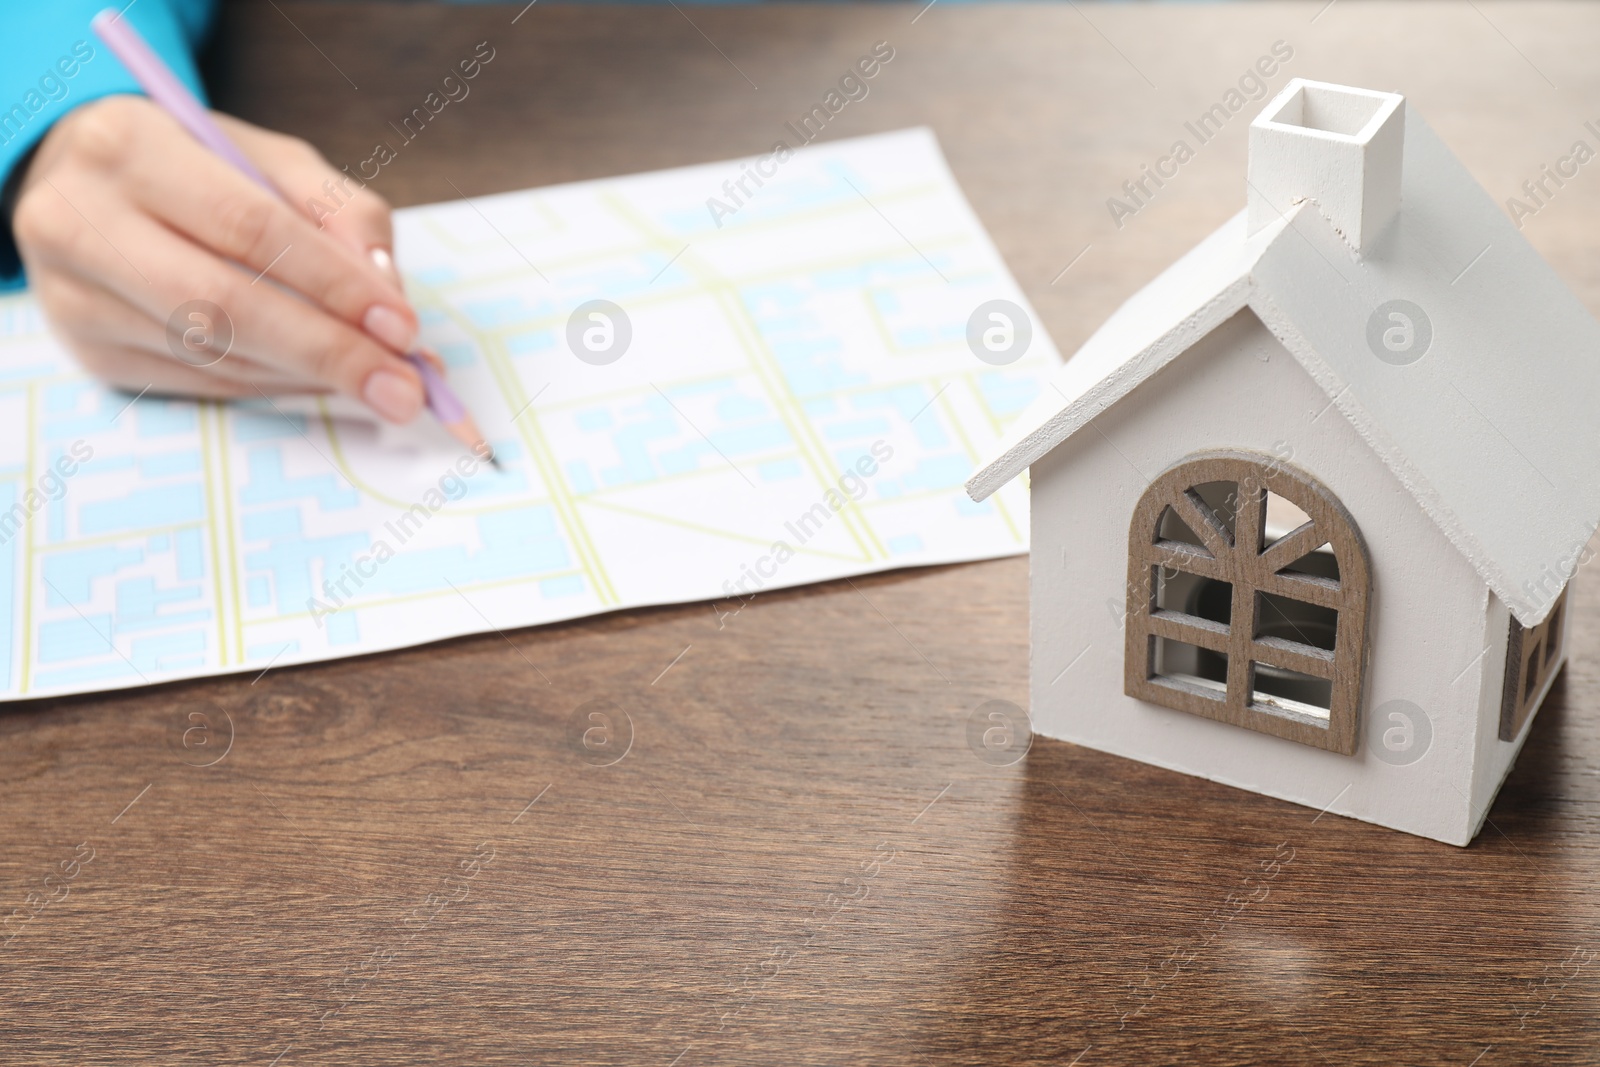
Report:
1123,451,1371,755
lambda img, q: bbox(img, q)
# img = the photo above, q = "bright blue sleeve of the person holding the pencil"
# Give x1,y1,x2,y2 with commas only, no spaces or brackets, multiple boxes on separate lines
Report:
0,0,216,293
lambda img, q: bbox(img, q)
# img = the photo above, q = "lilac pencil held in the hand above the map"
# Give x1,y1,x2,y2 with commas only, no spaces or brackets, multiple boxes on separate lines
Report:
90,8,499,469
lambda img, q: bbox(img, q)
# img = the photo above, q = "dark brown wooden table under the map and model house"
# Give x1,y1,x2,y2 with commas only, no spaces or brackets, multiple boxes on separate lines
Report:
0,0,1600,1067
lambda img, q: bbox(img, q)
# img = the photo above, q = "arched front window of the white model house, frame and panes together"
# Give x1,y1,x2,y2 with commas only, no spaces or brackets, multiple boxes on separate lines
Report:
1125,451,1371,755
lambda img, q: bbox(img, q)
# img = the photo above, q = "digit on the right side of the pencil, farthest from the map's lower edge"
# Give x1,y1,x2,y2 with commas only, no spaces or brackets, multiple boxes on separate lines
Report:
216,115,400,262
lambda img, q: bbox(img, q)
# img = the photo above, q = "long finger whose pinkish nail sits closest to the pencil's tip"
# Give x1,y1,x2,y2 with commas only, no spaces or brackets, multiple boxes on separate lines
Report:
33,204,422,422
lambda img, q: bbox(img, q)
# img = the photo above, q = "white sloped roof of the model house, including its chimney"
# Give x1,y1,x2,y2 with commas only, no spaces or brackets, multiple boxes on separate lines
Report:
966,78,1600,625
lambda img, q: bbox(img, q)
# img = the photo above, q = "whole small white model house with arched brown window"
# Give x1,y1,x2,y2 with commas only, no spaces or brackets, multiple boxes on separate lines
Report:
968,80,1600,845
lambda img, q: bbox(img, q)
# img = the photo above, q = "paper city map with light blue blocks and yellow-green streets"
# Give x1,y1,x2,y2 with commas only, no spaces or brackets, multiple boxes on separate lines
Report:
0,130,1059,699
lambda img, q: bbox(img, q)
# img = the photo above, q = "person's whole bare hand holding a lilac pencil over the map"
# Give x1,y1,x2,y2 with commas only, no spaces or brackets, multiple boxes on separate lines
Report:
13,96,422,422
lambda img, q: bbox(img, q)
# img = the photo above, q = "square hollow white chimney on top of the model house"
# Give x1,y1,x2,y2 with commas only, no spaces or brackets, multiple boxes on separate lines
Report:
1248,78,1405,250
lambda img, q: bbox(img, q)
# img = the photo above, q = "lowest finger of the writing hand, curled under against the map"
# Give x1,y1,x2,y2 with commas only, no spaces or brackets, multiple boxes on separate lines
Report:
30,270,323,392
